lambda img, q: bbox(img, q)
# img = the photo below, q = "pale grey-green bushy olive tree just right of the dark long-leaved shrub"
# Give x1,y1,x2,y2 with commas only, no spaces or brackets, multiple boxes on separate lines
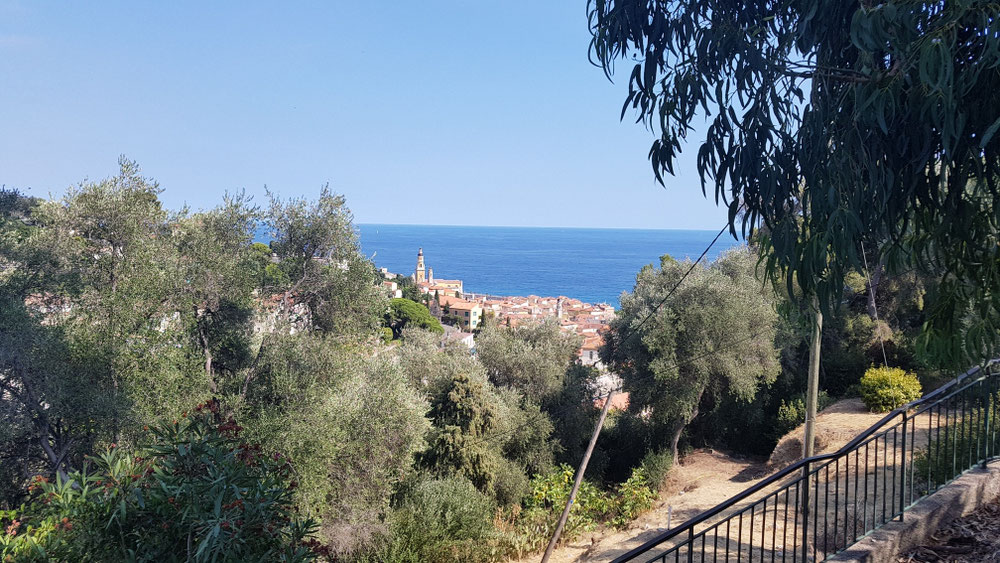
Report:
236,332,430,554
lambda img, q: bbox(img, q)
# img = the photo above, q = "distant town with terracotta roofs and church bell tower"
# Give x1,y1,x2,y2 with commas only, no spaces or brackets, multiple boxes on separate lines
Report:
380,248,615,368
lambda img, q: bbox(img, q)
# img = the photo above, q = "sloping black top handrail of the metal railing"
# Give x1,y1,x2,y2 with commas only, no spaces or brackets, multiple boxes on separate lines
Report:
612,359,998,563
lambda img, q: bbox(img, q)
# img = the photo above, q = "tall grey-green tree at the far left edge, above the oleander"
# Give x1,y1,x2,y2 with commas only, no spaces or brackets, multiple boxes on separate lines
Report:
0,158,202,498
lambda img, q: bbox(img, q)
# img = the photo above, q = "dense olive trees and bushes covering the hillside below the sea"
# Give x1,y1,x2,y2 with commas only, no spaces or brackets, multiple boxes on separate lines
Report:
0,160,948,561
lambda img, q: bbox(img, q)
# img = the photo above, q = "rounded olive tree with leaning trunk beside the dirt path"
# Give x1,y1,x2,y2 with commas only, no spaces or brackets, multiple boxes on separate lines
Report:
601,248,779,459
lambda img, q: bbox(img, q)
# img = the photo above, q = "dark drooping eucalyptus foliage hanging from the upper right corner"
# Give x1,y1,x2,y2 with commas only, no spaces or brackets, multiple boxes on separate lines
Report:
588,0,1000,363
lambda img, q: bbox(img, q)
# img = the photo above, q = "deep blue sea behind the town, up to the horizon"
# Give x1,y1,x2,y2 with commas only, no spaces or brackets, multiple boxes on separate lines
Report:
359,224,738,306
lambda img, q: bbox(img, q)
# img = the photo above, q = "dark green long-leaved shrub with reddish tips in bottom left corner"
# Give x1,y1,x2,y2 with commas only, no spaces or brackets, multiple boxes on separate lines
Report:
0,403,326,561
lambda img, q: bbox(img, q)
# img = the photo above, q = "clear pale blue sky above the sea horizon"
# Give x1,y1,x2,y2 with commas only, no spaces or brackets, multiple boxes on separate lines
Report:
0,0,725,229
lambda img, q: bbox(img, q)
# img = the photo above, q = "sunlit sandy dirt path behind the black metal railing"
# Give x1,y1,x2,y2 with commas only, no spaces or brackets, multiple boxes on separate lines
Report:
522,399,883,563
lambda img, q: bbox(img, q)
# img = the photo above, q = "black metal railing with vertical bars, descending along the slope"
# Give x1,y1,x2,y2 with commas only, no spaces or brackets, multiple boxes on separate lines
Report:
614,370,1000,563
